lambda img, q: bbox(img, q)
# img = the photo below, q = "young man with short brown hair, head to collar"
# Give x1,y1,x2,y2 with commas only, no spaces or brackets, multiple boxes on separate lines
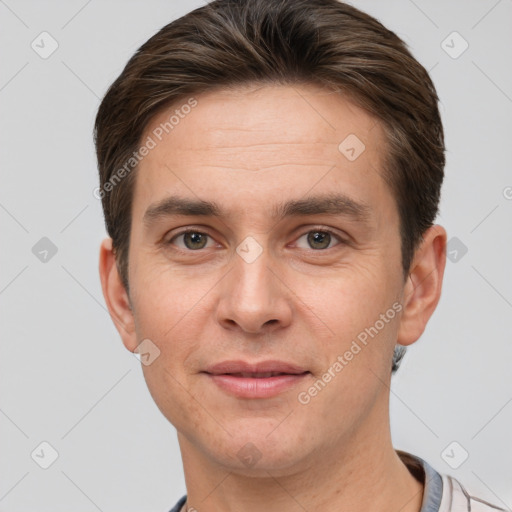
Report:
95,0,500,512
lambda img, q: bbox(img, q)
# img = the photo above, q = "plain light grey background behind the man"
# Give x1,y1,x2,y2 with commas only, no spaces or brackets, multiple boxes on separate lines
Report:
0,0,512,512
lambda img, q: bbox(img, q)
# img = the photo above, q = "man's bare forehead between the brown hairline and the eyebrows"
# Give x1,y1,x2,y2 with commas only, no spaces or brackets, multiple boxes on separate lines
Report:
134,85,389,219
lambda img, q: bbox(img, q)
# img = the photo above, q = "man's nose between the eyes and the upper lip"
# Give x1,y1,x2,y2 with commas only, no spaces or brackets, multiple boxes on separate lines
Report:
217,244,293,334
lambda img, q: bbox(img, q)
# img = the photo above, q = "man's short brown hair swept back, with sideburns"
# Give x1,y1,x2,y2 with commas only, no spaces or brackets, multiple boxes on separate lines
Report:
94,0,445,371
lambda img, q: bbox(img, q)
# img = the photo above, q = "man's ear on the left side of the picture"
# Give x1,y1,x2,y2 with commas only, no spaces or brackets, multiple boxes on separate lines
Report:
99,238,137,352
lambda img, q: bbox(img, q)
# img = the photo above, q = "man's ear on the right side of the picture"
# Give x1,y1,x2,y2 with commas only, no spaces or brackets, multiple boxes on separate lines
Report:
397,225,446,346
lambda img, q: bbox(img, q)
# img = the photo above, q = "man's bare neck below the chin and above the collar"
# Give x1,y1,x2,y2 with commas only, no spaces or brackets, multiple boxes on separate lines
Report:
178,390,423,512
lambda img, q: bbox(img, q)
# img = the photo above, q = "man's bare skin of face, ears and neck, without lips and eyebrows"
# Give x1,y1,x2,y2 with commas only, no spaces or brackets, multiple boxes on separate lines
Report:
100,85,446,512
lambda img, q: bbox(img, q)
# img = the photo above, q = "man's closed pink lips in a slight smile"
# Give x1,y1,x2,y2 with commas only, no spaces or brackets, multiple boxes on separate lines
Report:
203,361,311,398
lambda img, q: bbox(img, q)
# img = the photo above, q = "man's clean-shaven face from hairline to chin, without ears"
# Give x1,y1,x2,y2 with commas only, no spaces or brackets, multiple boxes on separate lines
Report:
110,85,410,474
